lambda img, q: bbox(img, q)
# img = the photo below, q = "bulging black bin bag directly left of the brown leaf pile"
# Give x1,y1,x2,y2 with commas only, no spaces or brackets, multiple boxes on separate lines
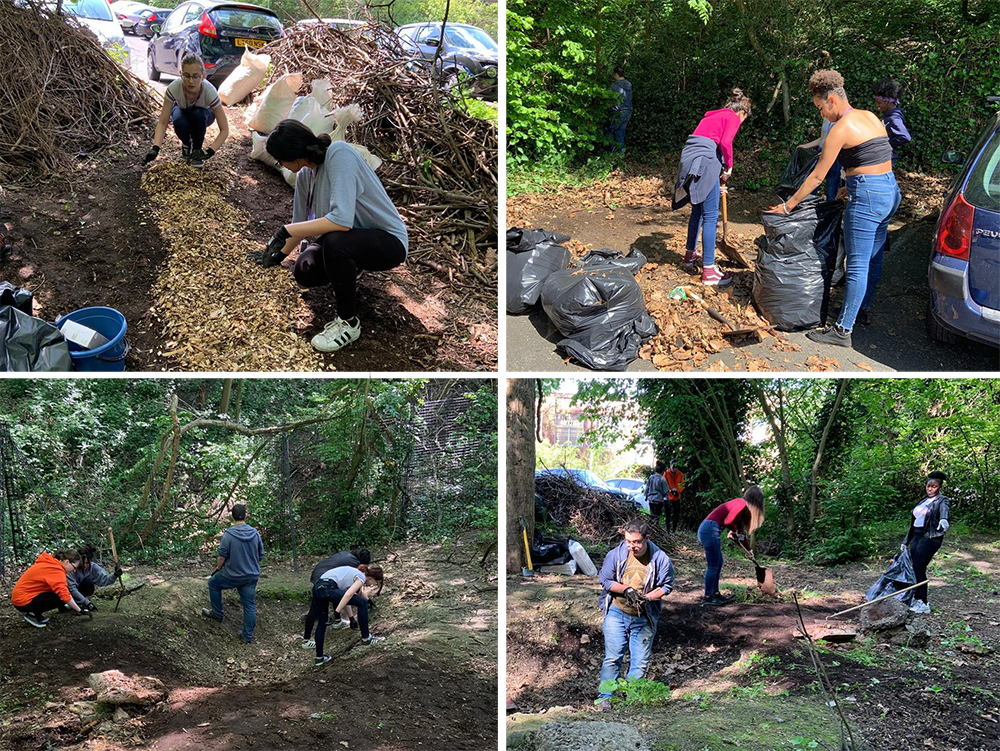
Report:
542,263,656,370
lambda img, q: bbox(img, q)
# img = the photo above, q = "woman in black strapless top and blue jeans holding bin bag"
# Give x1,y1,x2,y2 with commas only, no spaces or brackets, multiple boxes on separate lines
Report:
773,70,900,347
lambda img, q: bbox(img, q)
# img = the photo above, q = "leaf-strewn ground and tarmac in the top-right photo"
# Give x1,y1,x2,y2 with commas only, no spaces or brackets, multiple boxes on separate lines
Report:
506,161,1000,372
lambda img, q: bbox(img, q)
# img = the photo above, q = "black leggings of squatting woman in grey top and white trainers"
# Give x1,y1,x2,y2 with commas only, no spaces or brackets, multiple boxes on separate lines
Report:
293,229,406,320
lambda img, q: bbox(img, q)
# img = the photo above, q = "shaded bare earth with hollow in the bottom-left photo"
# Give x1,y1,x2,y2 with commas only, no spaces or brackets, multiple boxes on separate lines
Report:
0,545,498,751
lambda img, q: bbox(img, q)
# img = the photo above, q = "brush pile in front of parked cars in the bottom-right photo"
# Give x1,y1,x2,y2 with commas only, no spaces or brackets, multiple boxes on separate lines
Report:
535,475,667,547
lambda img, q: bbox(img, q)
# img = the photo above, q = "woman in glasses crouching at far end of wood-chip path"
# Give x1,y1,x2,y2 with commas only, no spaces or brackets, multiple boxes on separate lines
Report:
142,53,229,169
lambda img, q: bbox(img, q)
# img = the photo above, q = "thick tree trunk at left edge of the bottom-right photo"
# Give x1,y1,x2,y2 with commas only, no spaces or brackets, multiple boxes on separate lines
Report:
507,378,535,573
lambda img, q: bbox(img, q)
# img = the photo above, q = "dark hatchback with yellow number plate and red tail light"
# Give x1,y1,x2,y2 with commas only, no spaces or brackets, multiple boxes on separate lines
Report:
146,0,285,83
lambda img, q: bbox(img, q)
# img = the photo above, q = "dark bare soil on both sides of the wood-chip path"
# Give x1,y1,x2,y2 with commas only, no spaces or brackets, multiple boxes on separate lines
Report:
0,94,498,372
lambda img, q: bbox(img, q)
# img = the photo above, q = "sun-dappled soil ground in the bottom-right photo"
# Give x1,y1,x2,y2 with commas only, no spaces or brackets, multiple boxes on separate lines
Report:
507,534,1000,751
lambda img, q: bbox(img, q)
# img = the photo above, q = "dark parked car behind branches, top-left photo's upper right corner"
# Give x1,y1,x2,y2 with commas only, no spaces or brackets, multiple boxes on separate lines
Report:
396,23,500,101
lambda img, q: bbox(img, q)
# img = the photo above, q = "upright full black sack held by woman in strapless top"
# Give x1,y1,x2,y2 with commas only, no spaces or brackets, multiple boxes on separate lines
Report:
753,196,844,331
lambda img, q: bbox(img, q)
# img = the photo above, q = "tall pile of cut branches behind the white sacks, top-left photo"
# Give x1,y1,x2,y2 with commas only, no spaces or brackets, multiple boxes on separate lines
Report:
265,24,499,299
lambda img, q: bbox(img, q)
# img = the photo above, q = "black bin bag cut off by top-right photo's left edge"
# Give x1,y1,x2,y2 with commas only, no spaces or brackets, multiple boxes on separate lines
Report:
507,227,572,313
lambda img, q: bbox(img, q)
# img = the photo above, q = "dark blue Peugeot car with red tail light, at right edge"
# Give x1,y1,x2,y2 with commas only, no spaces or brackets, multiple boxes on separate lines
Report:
927,104,1000,347
